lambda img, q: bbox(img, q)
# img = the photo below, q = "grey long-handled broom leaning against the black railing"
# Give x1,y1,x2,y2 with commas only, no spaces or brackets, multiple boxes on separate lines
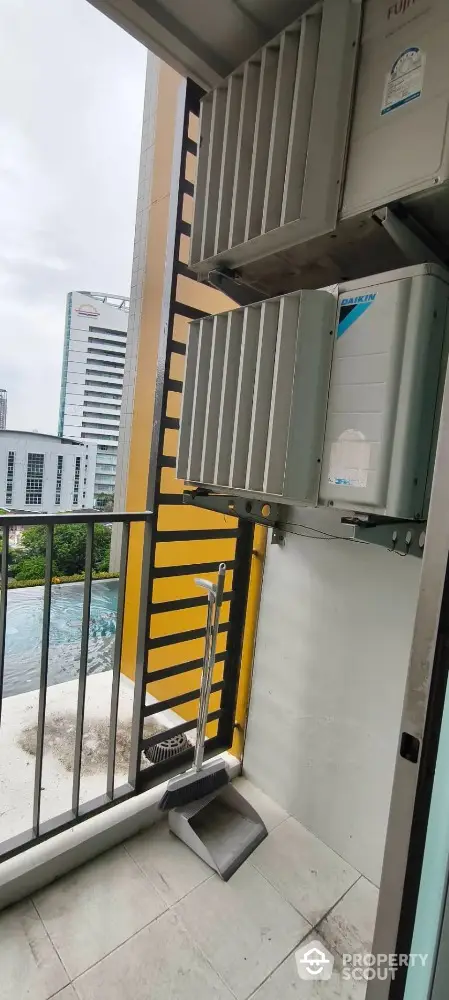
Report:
159,563,229,811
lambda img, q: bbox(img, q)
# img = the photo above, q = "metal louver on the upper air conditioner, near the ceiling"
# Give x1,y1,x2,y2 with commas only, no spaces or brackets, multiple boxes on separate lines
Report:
191,0,361,274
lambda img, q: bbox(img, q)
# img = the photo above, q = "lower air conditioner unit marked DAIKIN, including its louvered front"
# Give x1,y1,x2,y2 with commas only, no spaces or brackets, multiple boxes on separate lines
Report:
177,264,449,519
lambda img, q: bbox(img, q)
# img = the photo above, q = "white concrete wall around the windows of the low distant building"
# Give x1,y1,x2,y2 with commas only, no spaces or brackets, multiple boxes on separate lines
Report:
0,431,97,514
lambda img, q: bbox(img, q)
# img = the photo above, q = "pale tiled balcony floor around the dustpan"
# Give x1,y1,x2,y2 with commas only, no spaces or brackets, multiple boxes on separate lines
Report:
0,779,377,1000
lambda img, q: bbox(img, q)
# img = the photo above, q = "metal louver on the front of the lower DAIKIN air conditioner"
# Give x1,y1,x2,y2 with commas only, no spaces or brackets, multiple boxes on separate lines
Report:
177,291,336,503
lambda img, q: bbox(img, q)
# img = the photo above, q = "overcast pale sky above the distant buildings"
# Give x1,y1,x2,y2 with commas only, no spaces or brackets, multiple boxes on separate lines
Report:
0,0,146,434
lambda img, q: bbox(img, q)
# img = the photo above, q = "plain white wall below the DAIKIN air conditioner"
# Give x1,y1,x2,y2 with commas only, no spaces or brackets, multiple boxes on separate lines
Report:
244,534,421,884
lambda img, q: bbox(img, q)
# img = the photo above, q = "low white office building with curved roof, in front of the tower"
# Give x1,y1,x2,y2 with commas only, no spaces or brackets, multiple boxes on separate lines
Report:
0,431,97,514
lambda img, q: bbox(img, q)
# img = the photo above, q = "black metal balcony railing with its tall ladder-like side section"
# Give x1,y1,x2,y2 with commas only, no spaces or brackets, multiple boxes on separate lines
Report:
0,81,254,860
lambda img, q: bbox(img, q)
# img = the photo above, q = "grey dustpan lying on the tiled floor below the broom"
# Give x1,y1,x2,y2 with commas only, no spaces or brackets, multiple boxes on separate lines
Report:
168,785,267,882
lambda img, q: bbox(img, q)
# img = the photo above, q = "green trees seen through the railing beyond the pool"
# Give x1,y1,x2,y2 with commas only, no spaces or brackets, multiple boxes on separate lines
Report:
12,524,111,580
